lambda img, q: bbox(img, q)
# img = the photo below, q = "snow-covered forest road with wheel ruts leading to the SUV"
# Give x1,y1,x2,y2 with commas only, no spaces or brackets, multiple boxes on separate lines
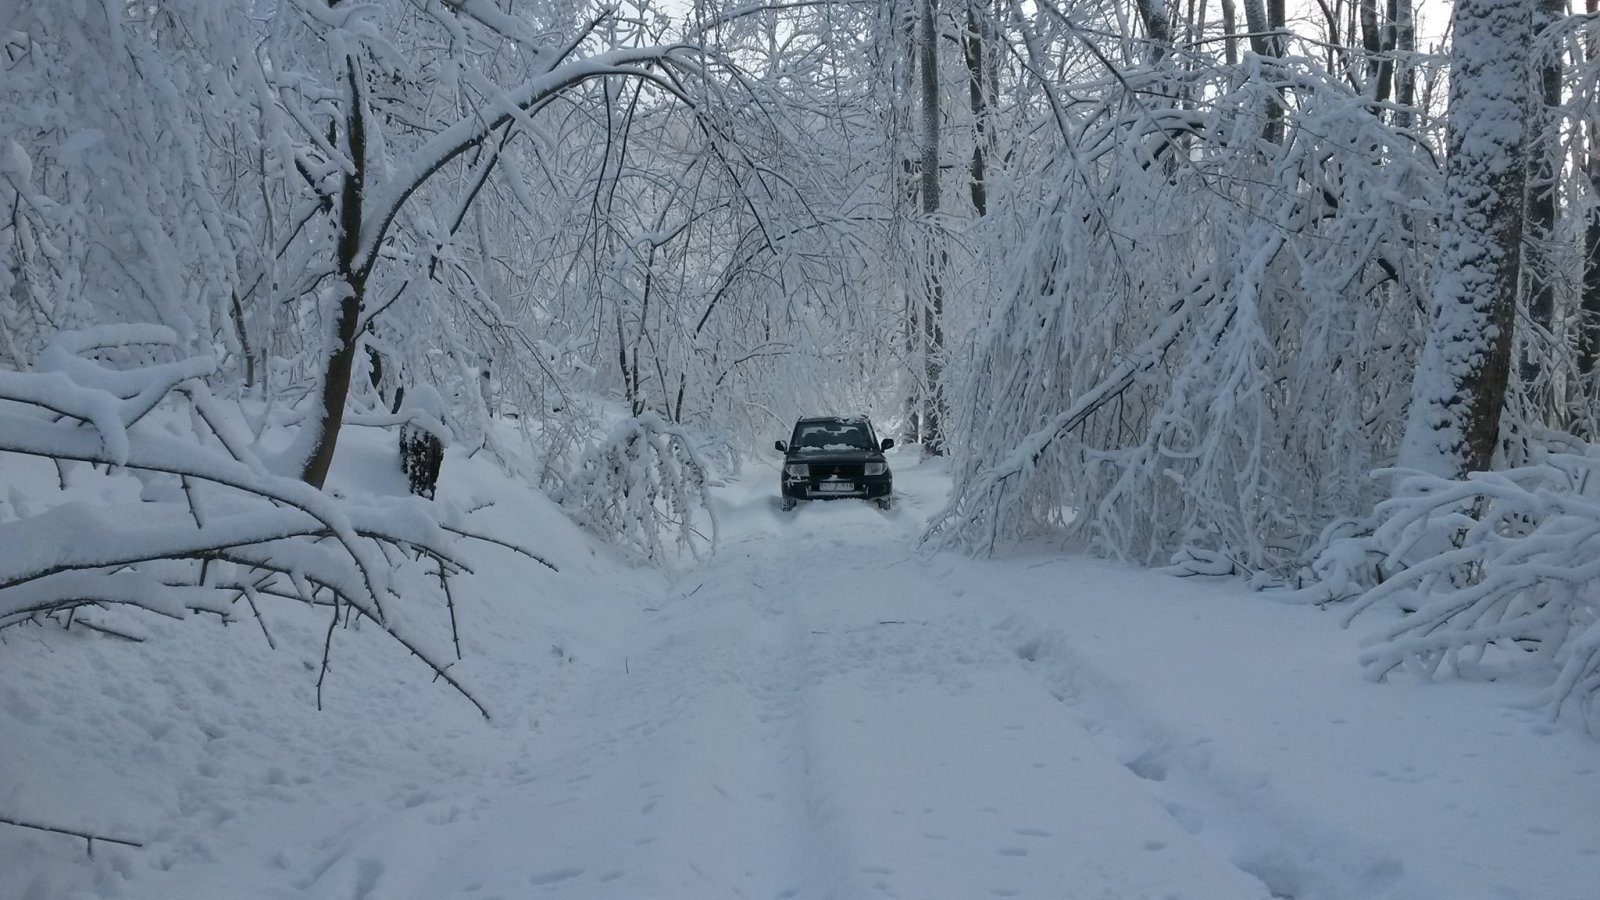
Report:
328,458,1267,900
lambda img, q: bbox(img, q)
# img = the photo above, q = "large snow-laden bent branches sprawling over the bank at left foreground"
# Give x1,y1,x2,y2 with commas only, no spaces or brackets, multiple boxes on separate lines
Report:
0,325,544,714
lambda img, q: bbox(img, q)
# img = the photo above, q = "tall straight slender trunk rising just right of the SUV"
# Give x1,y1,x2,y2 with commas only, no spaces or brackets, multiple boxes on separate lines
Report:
917,0,944,456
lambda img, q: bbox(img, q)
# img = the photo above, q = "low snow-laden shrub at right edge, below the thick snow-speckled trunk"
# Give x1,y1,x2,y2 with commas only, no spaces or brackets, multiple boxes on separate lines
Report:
1320,447,1600,730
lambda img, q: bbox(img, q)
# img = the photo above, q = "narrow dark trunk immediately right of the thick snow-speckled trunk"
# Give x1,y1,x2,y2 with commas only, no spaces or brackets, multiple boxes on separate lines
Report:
1522,0,1566,420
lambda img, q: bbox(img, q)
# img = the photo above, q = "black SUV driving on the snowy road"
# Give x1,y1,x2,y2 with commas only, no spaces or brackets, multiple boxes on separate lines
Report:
774,416,894,509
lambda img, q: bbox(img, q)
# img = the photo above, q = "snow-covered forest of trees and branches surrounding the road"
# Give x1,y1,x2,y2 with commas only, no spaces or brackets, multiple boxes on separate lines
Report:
0,0,1600,729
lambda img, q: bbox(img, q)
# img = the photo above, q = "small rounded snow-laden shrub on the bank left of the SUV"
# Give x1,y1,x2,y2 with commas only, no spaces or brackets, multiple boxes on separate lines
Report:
555,413,717,562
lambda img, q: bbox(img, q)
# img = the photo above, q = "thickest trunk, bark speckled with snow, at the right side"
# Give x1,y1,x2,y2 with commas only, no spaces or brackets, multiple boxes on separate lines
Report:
1400,0,1533,477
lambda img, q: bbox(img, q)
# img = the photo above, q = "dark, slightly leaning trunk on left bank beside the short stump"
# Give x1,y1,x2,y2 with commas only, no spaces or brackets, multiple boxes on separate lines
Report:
301,56,370,488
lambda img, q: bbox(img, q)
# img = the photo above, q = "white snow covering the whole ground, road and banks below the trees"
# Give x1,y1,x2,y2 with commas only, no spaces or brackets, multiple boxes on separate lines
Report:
0,432,1600,900
